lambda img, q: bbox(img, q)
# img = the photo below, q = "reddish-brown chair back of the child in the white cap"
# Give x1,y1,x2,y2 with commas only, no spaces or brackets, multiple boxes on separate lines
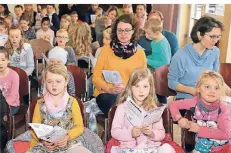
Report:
67,65,87,98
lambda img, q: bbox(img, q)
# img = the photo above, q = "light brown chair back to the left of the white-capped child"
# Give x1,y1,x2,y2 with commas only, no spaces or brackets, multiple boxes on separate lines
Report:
30,39,52,78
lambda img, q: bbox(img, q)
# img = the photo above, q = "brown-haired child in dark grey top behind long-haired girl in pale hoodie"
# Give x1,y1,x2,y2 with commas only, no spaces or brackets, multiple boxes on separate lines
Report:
19,15,36,42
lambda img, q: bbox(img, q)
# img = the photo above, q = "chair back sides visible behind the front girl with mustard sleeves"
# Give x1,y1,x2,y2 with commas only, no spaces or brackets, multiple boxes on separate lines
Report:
26,97,87,129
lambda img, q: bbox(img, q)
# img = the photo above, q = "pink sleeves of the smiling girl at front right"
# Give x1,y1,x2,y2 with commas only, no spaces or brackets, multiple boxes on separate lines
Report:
170,97,231,140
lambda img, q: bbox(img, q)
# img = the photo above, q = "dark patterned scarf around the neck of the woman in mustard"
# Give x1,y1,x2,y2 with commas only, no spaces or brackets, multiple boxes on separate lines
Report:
110,39,137,59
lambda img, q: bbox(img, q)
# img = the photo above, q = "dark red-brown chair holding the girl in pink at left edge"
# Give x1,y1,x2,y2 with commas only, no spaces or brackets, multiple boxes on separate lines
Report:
10,67,30,138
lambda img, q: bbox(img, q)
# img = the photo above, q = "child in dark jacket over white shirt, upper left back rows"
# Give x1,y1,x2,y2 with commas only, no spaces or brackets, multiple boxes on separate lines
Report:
47,4,60,33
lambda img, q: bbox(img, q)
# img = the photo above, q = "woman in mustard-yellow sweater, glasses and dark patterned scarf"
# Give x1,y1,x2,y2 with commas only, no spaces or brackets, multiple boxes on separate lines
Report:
93,15,147,116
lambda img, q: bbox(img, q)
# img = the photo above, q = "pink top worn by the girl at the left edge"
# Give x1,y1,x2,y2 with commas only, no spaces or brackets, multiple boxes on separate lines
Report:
0,69,19,106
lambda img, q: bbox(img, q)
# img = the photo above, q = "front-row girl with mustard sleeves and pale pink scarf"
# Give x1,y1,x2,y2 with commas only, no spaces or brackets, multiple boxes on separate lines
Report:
29,64,91,153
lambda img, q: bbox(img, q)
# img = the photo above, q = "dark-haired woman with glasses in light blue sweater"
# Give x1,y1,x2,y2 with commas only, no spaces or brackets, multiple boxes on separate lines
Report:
168,16,231,151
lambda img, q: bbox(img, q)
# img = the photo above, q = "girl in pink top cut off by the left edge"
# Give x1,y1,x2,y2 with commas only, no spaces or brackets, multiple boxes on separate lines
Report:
0,47,19,115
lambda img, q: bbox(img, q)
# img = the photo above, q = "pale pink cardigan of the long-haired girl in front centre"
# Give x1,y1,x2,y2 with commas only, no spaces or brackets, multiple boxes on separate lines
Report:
111,103,165,148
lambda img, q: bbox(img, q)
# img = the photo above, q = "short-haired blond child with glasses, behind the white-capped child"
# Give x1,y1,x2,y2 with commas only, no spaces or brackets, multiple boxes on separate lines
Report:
56,29,77,65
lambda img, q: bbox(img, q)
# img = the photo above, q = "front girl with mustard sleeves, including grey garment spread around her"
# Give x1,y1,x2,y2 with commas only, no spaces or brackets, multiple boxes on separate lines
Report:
7,64,104,153
